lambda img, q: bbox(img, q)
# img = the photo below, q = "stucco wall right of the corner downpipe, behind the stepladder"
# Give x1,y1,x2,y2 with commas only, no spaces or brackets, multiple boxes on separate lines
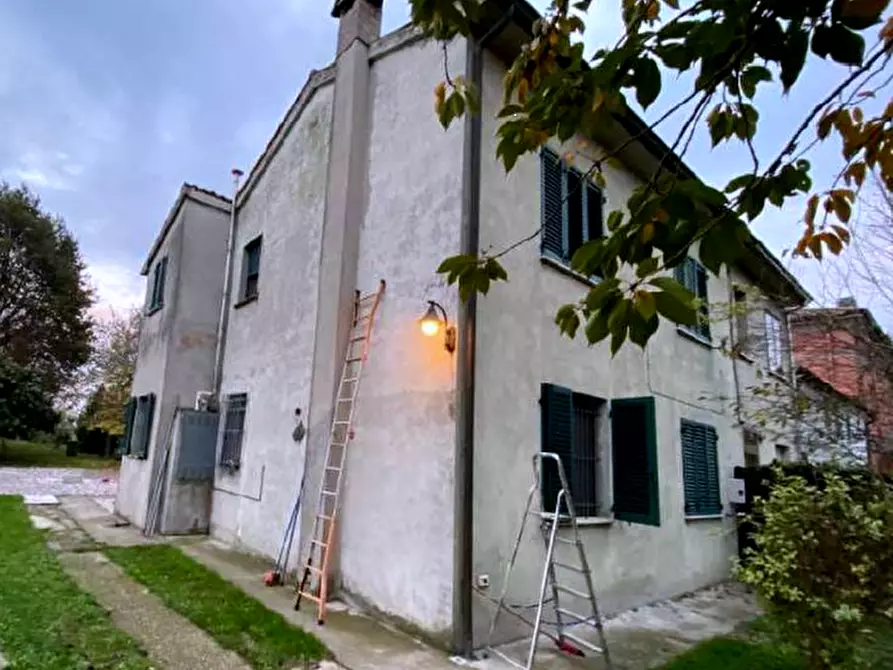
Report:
474,48,743,634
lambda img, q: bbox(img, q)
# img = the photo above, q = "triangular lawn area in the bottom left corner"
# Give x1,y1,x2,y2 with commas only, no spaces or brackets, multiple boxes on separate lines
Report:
0,496,151,670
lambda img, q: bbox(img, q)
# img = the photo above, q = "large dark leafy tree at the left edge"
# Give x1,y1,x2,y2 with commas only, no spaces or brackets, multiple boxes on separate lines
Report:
0,182,93,394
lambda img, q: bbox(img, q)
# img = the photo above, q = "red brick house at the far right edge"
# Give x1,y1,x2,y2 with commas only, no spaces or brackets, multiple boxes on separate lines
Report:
791,298,893,472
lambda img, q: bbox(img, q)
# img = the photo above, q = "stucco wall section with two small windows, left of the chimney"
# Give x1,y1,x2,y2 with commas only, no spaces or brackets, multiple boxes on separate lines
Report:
211,85,333,567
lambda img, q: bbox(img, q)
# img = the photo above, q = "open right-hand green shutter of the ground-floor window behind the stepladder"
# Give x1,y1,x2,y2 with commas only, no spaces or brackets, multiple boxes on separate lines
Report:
611,397,660,526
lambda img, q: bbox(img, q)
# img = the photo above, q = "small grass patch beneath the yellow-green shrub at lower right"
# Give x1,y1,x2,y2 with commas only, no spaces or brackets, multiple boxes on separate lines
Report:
662,617,893,670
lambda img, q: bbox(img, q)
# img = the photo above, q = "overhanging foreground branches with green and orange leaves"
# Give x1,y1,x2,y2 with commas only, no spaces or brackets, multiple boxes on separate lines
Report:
411,0,893,351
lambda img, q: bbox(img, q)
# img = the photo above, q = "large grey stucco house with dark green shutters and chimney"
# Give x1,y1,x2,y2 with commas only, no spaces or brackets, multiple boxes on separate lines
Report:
118,0,808,651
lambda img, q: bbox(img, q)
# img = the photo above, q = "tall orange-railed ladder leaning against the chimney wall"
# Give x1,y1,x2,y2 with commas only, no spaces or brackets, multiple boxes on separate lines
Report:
295,279,385,624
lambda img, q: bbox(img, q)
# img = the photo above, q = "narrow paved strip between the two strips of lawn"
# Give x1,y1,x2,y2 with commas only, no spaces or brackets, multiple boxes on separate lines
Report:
59,552,250,670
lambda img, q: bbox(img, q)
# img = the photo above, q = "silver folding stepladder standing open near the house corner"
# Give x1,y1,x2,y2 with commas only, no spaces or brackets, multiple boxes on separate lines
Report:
487,452,614,670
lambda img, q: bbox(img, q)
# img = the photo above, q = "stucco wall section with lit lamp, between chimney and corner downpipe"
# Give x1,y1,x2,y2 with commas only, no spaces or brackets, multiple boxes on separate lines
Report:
340,35,464,635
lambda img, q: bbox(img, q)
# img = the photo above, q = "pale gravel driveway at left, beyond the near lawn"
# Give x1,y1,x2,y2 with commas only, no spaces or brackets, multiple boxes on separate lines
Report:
0,468,118,497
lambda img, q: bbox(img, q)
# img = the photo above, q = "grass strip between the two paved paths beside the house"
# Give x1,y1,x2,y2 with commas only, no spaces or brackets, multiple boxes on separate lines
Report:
105,545,330,670
